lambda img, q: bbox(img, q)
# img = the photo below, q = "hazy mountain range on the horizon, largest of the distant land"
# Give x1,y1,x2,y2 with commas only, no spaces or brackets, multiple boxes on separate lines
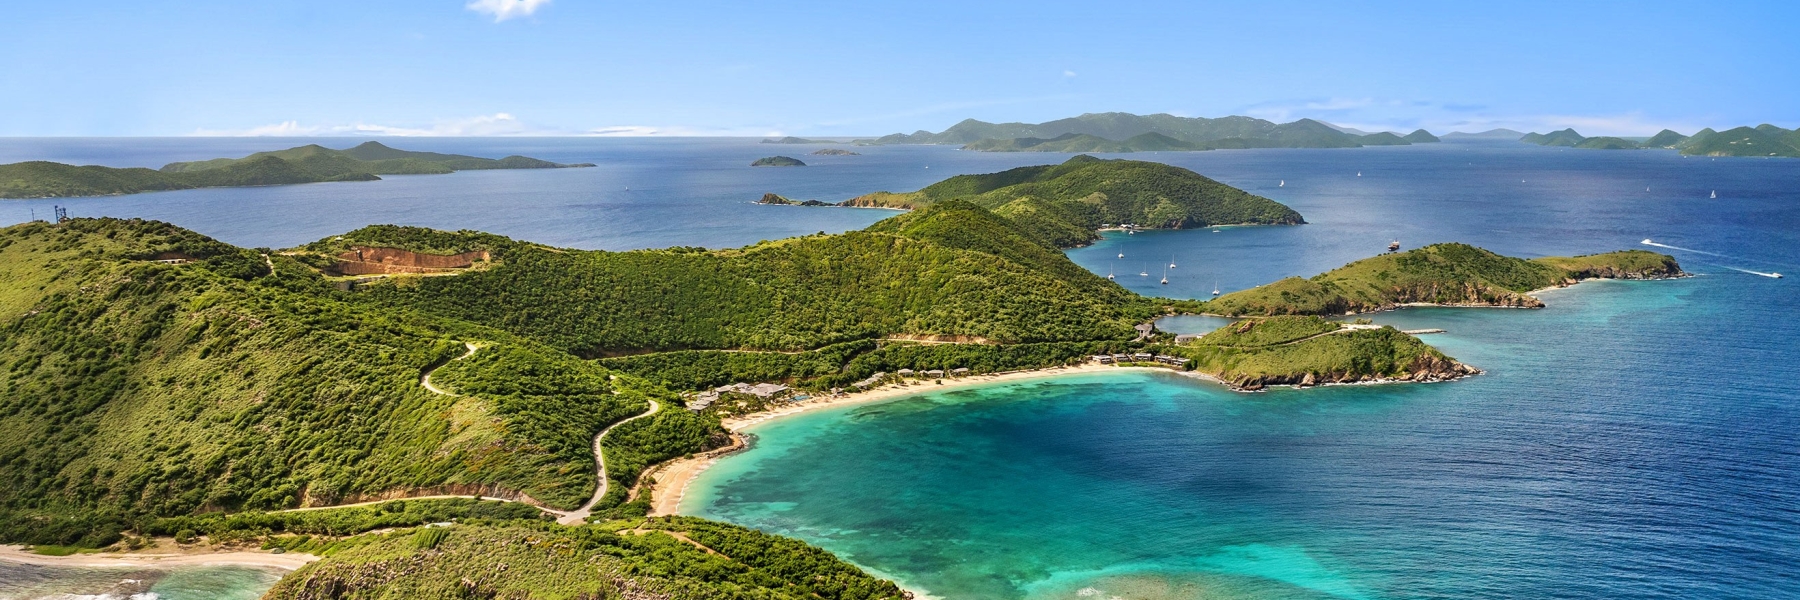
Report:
855,112,1438,153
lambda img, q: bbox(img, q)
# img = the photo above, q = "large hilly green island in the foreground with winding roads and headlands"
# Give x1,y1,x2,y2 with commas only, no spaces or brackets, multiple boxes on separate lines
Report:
0,157,1679,600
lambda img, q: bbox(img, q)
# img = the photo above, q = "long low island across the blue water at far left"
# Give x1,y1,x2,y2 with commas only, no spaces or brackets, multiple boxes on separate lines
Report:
0,141,594,198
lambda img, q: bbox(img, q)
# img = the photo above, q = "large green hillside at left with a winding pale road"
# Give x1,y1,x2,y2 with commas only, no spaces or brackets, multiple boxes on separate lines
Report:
0,220,680,542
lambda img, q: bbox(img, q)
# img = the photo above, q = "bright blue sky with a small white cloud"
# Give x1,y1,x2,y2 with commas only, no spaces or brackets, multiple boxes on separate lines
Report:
0,0,1800,135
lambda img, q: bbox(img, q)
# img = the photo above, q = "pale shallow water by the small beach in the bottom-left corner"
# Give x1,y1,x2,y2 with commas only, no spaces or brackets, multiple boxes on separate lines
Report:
0,562,284,600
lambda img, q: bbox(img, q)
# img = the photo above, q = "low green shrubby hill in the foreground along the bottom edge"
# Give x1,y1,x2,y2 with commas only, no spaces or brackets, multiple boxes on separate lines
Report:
265,517,904,600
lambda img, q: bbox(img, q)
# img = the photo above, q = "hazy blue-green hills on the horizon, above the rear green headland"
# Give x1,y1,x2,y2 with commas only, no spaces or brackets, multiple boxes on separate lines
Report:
857,112,1418,151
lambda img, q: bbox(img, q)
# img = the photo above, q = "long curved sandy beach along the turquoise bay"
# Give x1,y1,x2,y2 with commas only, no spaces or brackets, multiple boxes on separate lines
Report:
650,362,1175,517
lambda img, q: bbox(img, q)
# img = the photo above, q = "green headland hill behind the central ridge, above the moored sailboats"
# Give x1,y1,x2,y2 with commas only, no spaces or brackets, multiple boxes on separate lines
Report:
846,155,1305,247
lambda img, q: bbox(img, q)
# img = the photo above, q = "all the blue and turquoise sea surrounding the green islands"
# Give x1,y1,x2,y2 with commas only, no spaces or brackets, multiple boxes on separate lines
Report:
0,139,1800,600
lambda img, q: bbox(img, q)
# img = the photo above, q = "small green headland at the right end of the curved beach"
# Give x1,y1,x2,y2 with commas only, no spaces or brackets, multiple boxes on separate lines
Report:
1157,317,1474,389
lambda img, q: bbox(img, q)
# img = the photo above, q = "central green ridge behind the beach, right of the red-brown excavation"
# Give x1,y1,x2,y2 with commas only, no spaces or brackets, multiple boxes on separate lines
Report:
358,205,1150,357
